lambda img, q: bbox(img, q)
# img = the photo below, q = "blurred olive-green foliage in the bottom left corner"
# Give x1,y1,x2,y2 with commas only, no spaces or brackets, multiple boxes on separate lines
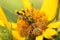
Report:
0,26,11,40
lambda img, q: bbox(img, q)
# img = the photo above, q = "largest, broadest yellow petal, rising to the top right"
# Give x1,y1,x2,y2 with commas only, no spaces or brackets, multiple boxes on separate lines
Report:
40,0,58,21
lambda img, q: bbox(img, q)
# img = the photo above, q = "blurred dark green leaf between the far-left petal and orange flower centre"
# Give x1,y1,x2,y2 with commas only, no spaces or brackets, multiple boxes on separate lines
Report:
2,7,18,22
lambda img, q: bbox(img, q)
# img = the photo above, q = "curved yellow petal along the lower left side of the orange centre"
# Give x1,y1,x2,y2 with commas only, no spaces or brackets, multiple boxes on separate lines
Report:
11,23,25,40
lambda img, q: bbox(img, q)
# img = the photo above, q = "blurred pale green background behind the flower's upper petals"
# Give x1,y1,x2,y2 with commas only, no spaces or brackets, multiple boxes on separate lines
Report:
0,0,43,22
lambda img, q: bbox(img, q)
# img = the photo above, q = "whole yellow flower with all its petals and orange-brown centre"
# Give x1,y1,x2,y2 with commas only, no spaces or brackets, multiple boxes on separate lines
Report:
0,0,60,40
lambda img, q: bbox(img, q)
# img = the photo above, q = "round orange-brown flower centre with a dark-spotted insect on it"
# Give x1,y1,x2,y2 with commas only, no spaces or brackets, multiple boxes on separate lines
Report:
17,10,47,36
